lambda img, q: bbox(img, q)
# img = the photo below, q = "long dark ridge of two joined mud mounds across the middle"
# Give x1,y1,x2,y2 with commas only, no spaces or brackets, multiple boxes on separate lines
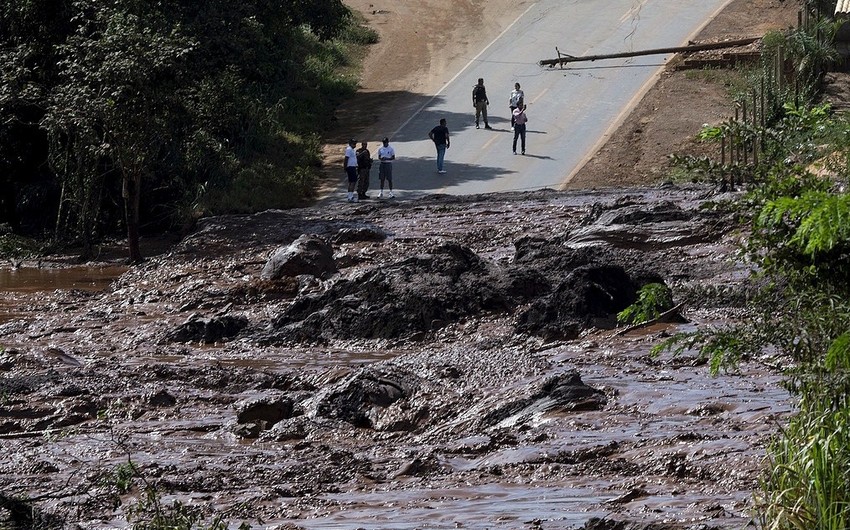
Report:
259,231,661,343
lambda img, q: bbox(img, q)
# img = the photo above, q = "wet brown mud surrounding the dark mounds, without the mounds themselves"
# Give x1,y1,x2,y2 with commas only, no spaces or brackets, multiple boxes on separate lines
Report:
0,190,791,530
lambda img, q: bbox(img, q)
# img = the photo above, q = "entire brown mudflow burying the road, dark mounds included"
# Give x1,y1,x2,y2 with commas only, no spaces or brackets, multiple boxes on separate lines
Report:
0,187,790,530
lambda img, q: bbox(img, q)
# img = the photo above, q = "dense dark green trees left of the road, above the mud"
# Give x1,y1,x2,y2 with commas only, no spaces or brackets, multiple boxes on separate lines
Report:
0,0,356,260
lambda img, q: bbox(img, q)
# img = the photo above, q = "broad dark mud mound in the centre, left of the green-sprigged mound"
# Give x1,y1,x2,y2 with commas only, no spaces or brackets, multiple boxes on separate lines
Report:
270,243,516,341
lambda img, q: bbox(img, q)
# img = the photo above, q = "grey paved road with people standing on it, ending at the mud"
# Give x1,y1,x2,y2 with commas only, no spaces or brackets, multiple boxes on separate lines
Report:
382,0,729,197
